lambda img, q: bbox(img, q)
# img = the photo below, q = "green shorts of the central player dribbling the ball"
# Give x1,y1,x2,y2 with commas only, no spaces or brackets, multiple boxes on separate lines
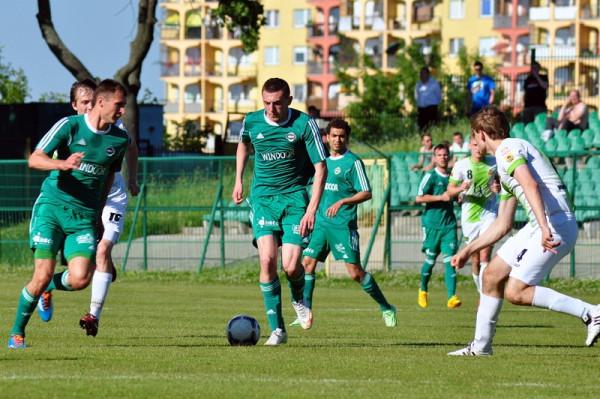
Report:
250,190,308,247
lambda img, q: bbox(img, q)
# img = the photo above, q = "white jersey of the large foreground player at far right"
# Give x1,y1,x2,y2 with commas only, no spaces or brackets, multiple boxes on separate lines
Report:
496,138,573,226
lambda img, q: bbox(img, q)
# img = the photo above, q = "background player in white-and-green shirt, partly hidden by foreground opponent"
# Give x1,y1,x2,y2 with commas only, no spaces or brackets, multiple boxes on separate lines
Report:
448,142,500,292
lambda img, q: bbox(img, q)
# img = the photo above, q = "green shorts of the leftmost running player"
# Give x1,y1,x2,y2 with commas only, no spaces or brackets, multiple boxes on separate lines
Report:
29,197,96,260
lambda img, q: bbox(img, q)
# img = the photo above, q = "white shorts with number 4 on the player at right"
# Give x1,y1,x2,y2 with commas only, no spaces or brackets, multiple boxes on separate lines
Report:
497,214,579,285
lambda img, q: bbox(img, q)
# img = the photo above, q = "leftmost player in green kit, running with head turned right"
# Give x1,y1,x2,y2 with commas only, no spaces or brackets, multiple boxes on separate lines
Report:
8,80,129,348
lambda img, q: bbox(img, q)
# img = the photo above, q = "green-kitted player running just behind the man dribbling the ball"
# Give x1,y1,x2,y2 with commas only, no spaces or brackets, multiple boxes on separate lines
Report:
303,119,397,327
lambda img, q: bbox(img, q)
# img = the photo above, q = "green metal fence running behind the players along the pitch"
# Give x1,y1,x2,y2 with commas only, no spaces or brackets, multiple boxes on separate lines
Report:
0,152,600,278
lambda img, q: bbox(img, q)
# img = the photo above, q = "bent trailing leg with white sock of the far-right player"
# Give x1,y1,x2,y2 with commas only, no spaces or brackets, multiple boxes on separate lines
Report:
505,220,600,346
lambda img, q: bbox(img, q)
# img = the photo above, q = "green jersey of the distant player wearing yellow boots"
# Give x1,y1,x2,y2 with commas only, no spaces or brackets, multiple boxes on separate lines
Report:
417,168,456,228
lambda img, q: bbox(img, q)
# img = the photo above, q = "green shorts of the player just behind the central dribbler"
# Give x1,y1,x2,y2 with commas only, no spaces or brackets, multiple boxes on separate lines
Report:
302,224,360,265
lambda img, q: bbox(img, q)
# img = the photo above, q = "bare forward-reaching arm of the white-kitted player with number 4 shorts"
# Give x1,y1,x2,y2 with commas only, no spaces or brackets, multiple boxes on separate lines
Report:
451,196,517,269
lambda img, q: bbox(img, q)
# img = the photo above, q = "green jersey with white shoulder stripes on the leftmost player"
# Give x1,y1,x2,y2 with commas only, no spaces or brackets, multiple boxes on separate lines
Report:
36,115,129,212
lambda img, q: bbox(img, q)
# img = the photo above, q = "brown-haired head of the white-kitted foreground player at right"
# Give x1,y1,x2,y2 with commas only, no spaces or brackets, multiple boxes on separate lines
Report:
471,106,510,154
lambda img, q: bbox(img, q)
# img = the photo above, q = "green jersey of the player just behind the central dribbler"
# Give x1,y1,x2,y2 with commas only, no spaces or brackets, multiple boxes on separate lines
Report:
317,151,371,230
